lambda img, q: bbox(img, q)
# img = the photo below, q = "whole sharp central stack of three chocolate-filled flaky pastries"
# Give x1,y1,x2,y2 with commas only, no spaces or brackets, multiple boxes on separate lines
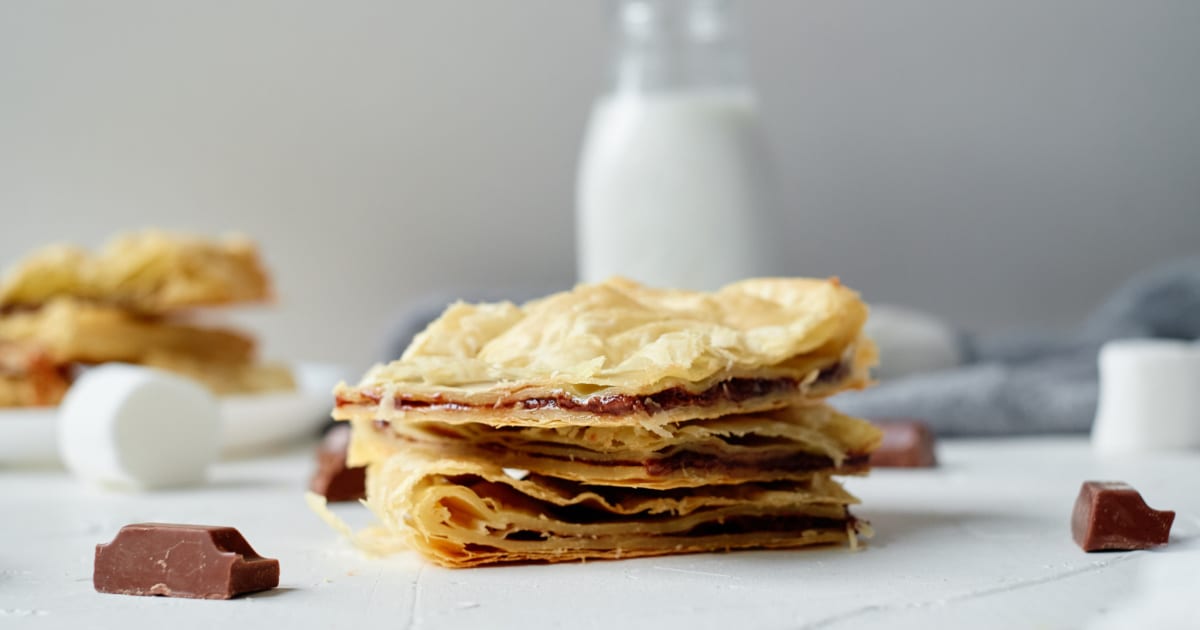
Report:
334,278,881,566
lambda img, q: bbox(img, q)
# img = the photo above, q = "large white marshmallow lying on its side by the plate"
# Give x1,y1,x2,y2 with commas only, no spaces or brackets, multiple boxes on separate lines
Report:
58,364,221,490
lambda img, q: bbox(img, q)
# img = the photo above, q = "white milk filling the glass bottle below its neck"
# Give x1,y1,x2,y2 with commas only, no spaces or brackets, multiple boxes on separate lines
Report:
576,88,774,289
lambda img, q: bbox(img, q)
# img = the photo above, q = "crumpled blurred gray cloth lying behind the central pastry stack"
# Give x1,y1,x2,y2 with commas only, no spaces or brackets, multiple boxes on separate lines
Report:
384,257,1200,436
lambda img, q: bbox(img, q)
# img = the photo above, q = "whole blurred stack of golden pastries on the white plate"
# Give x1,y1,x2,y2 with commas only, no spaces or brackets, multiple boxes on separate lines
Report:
0,232,294,407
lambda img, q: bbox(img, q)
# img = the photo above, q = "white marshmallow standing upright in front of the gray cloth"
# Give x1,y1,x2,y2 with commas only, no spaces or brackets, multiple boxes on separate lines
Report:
1092,340,1200,454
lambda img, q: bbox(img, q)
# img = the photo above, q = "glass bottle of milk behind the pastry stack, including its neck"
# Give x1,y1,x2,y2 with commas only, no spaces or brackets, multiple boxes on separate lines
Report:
576,0,776,289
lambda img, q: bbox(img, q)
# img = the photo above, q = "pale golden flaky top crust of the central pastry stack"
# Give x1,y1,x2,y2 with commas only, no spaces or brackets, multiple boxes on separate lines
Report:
337,278,866,403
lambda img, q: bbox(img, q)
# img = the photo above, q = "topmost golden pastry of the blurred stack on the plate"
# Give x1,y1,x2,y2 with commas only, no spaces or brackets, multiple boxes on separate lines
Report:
0,230,271,313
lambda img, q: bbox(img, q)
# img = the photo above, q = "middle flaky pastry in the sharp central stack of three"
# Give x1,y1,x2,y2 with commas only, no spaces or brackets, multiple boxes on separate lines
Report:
350,406,881,490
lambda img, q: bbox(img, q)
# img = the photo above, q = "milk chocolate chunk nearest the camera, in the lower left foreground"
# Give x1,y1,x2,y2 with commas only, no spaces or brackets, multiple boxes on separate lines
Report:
92,523,280,599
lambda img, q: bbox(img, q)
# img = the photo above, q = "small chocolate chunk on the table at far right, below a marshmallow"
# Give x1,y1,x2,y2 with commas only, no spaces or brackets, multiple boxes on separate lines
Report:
1070,481,1175,551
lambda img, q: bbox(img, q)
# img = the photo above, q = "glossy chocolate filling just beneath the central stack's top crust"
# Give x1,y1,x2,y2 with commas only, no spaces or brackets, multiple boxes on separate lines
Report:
337,362,852,415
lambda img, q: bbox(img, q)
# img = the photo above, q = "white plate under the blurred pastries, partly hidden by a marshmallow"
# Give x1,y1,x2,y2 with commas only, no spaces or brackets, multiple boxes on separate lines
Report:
0,364,347,464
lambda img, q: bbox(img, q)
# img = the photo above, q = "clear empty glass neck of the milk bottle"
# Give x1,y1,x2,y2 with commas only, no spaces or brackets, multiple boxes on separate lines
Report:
613,0,750,94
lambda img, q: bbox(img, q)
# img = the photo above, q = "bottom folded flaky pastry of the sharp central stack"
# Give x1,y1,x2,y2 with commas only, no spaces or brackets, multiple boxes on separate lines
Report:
367,454,866,568
